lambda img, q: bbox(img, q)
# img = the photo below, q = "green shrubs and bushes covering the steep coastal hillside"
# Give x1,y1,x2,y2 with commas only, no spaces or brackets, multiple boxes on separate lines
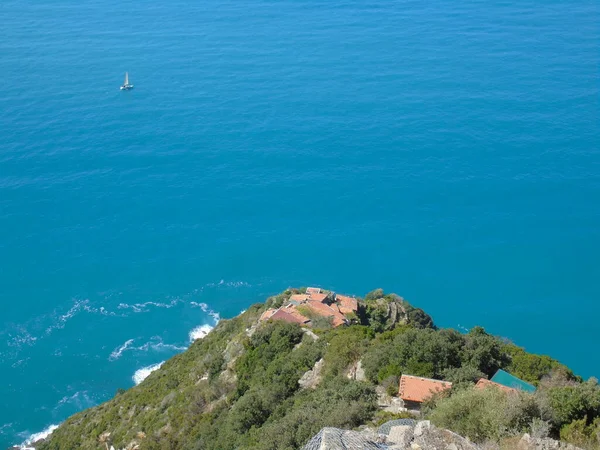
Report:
40,289,600,450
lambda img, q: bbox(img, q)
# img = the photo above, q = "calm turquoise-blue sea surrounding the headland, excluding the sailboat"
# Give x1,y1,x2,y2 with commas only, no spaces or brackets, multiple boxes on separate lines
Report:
0,0,600,448
